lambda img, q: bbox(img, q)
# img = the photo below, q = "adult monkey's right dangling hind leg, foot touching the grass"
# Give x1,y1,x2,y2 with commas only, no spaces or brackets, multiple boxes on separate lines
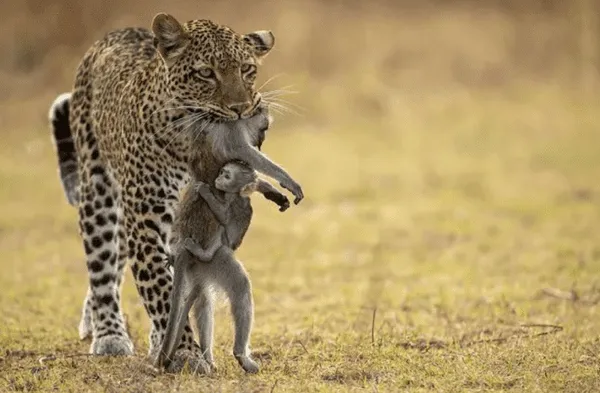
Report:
211,247,259,373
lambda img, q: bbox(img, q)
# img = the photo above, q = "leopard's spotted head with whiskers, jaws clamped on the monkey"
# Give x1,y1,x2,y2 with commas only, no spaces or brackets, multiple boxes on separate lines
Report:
152,13,275,121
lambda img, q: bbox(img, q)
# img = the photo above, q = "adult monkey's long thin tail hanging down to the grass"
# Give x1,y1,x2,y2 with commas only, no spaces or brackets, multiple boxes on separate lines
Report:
155,251,197,368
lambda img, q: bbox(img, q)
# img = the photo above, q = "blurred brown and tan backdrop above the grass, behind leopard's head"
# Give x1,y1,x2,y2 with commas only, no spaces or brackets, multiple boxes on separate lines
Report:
0,0,600,125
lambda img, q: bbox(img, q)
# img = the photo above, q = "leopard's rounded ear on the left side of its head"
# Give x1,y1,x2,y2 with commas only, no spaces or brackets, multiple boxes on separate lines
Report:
152,13,189,62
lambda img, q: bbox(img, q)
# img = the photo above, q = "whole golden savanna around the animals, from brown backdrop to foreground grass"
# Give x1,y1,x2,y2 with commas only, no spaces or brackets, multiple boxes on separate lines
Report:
0,0,600,393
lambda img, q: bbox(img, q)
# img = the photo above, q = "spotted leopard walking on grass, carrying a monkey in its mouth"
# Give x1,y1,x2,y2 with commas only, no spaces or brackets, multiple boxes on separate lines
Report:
49,13,303,373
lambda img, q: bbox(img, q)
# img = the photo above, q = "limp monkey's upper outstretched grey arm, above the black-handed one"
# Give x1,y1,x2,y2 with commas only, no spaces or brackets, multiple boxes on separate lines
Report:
231,143,304,205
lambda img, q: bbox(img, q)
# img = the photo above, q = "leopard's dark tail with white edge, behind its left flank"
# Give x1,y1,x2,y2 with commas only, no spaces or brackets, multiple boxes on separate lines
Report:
48,93,79,206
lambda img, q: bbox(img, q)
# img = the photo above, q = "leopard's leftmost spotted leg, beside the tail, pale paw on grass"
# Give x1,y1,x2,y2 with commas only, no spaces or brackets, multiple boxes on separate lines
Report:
69,79,133,355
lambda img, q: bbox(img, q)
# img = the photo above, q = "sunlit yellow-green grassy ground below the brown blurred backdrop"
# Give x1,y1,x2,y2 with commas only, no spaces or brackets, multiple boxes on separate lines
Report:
0,83,600,393
